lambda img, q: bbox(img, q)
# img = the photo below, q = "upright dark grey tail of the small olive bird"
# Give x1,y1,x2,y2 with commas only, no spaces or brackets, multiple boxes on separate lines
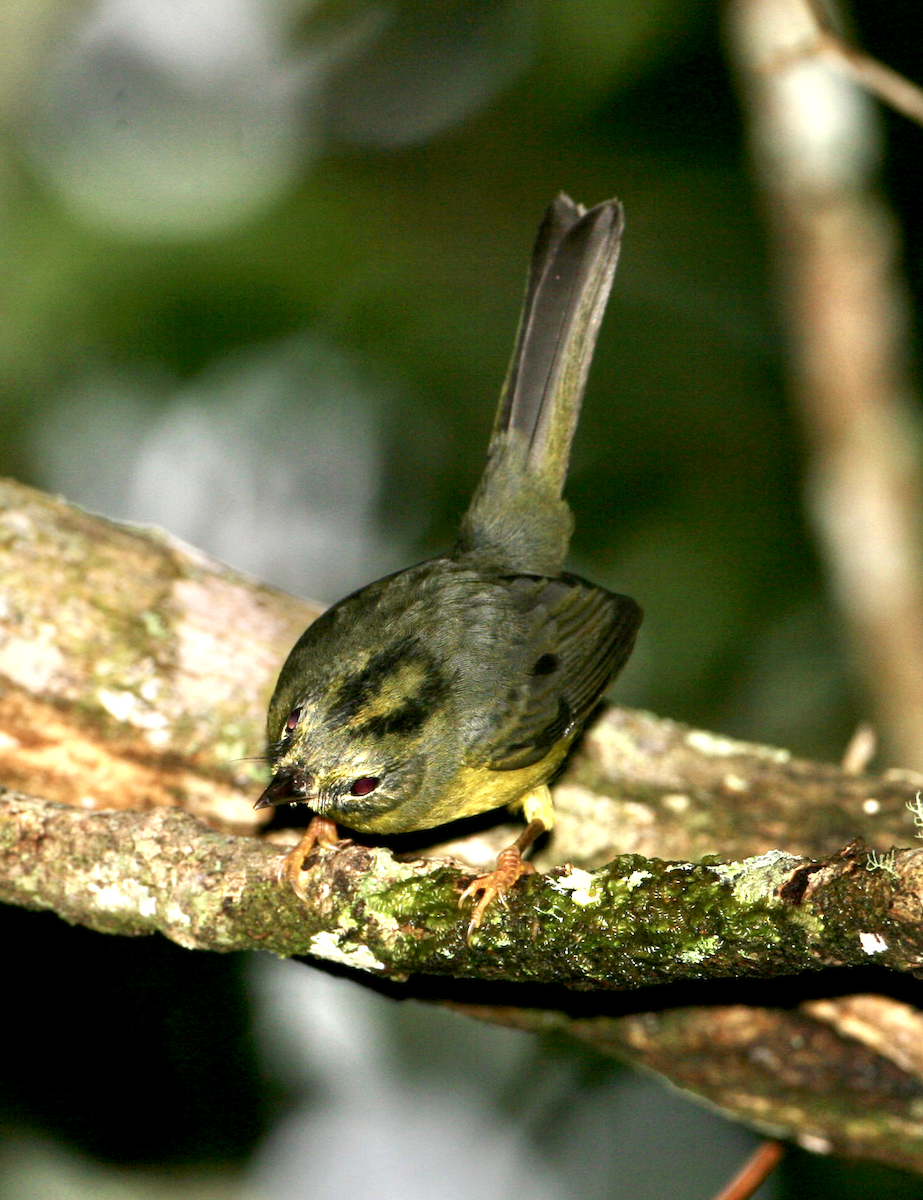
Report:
455,194,624,574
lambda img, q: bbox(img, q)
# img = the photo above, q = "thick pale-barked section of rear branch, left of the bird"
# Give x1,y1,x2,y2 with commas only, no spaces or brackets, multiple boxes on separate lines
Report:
0,480,319,832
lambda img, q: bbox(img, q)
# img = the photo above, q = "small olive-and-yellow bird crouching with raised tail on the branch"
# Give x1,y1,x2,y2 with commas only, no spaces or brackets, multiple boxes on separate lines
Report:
256,194,641,938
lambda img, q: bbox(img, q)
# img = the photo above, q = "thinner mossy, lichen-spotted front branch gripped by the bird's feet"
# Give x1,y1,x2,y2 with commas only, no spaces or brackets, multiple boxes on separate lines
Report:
0,792,923,990
